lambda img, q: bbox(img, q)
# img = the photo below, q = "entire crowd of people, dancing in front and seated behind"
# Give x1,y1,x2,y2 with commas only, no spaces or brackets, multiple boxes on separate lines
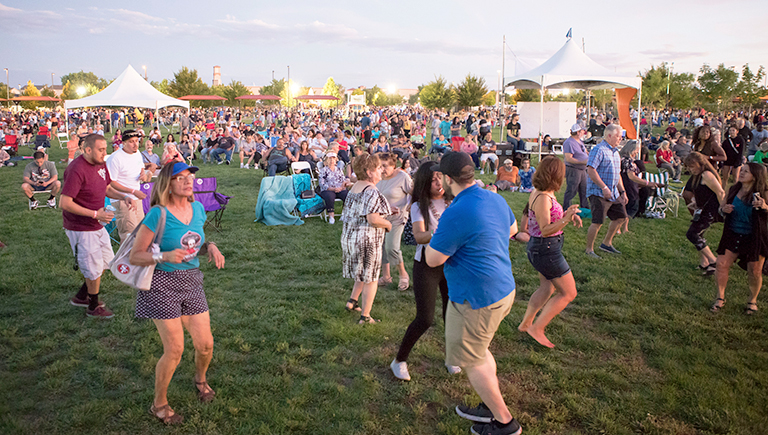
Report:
3,100,768,434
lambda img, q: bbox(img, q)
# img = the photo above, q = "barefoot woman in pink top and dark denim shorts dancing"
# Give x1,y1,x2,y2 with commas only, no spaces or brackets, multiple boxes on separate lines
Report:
517,156,581,348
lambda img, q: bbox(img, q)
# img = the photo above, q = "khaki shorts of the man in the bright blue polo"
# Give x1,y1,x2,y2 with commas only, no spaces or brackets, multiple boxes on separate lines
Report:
445,290,515,367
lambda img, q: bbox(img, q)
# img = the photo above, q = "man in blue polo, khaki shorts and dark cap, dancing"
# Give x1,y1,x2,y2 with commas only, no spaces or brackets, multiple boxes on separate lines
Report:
425,152,522,435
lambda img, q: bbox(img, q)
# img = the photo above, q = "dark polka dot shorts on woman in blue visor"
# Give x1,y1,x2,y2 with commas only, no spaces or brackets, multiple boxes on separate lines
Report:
136,269,208,319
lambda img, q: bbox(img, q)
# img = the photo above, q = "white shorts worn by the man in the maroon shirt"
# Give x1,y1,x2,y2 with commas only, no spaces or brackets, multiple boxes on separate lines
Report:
64,228,115,281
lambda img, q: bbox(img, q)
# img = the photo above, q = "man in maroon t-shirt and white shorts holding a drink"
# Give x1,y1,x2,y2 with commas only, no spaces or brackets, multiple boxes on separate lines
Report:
61,134,136,319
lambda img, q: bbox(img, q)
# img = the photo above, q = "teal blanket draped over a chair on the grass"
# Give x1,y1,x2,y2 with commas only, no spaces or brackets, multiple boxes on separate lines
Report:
256,176,304,225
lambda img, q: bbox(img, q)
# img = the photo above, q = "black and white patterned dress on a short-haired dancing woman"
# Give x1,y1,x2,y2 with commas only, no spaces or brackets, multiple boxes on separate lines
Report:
341,186,392,282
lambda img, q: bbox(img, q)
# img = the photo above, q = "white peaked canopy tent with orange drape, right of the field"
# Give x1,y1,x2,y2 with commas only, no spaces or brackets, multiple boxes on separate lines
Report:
504,38,642,160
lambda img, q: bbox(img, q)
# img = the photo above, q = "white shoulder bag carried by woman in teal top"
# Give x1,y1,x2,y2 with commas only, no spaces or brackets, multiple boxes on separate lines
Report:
109,206,166,291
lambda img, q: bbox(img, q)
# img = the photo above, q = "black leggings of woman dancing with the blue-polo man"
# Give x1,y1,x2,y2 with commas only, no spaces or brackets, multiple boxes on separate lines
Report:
397,255,448,362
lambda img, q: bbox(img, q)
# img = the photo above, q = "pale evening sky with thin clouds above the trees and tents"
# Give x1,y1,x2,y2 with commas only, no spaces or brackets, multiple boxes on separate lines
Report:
0,0,768,90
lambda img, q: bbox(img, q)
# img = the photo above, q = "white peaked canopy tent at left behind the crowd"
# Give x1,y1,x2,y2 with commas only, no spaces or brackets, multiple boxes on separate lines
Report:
64,65,189,134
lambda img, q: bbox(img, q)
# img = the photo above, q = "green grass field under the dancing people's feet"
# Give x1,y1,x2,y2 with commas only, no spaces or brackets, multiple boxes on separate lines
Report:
0,124,768,434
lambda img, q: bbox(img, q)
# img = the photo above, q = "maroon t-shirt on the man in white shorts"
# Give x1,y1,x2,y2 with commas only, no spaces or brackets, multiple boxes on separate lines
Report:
61,155,112,231
